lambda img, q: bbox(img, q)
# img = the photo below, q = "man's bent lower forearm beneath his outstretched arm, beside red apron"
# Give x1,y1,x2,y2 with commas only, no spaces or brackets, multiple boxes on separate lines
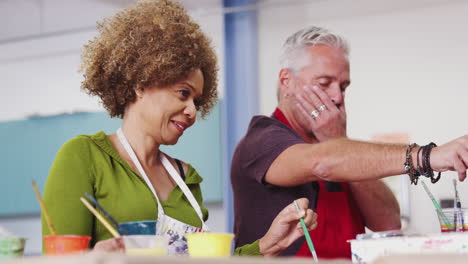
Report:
350,180,401,232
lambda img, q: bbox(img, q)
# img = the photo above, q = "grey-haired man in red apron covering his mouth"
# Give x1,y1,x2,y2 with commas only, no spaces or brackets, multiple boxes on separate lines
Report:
231,27,468,258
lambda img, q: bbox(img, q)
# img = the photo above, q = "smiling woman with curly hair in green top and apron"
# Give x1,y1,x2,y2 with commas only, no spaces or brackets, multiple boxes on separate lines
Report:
43,0,316,255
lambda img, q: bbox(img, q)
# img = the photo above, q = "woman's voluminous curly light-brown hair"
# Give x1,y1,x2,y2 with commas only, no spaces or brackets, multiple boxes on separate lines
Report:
81,0,218,118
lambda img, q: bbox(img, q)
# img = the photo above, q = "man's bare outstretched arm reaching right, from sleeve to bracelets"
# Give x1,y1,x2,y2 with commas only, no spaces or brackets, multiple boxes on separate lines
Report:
266,138,410,186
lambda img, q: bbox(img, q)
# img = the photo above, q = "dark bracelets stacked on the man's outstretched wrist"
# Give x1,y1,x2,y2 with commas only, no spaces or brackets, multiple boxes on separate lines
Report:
404,142,441,185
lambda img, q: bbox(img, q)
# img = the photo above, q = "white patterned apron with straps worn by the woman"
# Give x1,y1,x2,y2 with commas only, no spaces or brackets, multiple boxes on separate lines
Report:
117,128,208,255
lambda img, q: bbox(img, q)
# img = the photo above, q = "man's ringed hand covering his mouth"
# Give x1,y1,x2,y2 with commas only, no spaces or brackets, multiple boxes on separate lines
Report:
295,86,346,142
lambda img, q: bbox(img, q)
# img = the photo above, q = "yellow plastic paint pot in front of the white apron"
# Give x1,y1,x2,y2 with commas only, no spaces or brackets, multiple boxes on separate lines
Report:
185,232,234,257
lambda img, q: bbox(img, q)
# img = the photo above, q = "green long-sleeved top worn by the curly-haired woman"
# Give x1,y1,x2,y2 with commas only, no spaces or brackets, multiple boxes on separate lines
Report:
42,131,260,255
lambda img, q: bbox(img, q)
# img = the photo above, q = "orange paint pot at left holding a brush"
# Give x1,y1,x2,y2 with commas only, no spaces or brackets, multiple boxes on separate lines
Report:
44,235,91,256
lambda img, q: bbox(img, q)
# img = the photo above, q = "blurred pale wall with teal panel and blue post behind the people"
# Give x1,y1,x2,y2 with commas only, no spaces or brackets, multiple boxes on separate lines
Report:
0,0,468,255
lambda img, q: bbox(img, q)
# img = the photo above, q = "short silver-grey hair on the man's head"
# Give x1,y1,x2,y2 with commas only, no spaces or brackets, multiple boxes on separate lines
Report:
280,26,349,71
